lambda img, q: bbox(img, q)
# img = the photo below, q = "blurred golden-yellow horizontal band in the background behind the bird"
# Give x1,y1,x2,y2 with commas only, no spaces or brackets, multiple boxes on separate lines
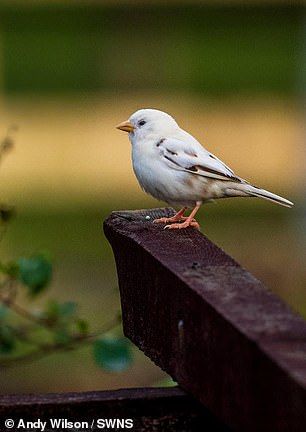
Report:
0,93,304,206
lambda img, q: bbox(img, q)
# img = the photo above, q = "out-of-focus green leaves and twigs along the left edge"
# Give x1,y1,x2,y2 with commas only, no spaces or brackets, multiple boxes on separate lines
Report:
0,128,131,371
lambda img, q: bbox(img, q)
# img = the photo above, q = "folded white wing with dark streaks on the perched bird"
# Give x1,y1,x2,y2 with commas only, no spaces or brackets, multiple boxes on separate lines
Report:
159,138,244,183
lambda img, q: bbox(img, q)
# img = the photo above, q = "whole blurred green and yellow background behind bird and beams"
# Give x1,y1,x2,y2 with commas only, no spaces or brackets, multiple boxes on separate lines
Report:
0,0,306,393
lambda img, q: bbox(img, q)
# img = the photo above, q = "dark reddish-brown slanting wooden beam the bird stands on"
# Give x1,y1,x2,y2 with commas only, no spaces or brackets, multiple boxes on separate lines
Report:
104,209,306,432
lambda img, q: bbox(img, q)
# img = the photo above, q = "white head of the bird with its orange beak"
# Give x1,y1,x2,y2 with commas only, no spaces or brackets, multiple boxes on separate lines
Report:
116,109,178,141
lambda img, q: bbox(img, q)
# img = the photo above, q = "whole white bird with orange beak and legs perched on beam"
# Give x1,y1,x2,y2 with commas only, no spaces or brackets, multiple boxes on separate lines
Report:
117,109,293,229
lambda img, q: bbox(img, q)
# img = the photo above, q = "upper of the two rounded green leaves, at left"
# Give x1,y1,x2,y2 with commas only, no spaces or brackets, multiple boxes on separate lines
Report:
17,255,52,296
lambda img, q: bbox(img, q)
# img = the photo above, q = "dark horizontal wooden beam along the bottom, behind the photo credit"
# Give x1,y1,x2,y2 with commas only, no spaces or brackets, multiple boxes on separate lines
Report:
0,387,227,432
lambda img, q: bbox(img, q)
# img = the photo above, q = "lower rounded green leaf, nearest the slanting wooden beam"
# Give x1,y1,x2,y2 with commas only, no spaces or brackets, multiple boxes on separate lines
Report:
93,336,132,372
